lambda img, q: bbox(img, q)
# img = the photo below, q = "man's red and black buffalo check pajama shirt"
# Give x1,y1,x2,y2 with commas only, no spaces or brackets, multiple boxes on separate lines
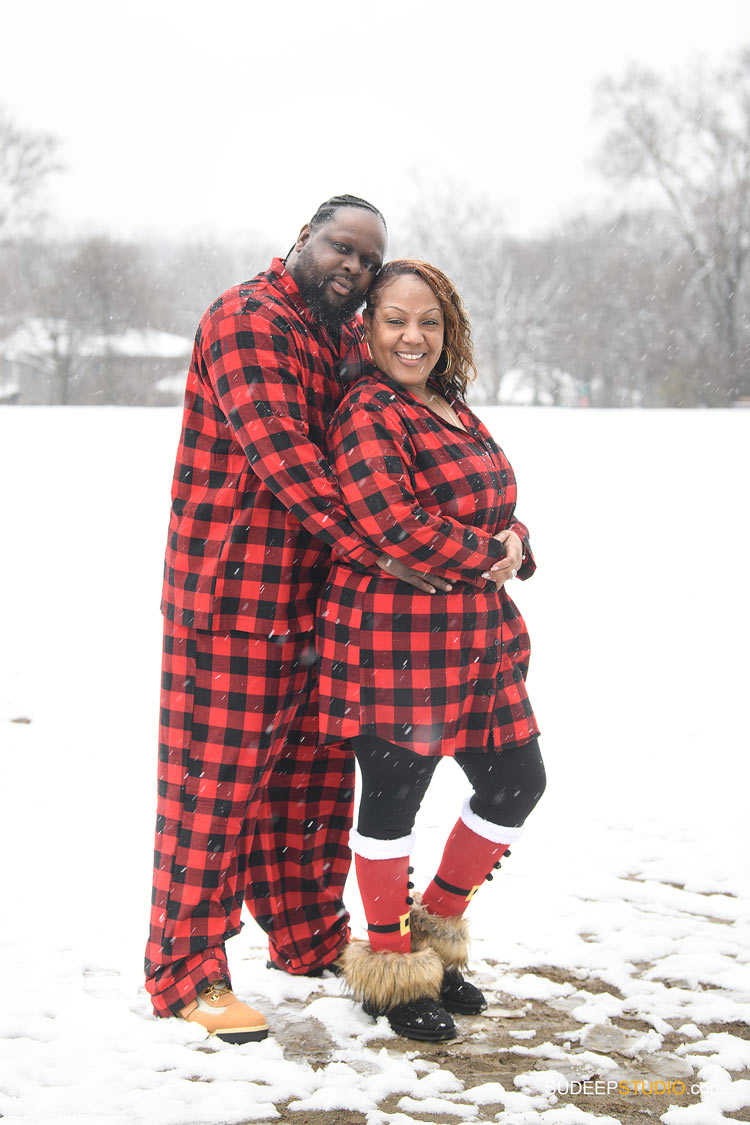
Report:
162,258,378,635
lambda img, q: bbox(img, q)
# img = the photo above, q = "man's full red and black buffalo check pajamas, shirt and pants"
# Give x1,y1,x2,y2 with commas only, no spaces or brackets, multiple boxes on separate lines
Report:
146,259,378,1015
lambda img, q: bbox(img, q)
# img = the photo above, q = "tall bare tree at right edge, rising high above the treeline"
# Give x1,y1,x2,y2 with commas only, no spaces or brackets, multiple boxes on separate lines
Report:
598,50,750,404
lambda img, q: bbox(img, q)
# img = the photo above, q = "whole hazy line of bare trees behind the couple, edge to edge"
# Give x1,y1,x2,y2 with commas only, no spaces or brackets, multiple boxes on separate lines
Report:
0,51,750,407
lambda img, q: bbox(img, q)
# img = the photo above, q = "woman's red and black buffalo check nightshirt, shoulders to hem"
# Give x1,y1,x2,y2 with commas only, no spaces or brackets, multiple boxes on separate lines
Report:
317,372,539,756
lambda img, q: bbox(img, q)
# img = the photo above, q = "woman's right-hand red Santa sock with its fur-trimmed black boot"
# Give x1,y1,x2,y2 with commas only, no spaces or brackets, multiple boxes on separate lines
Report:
410,801,521,1015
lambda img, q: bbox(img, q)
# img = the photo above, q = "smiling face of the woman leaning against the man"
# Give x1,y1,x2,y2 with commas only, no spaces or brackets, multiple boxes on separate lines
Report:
364,273,443,387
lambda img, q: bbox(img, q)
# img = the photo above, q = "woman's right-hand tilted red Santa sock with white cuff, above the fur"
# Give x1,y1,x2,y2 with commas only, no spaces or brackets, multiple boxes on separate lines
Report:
422,801,523,917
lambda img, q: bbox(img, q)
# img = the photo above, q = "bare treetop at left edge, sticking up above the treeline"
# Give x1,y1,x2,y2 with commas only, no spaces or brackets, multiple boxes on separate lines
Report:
0,109,58,240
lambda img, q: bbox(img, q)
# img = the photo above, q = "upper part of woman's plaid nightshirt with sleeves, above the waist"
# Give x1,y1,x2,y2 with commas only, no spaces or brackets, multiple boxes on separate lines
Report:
328,368,536,590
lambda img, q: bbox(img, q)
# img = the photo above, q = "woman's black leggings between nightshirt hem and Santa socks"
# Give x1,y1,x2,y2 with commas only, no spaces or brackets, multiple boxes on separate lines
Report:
352,735,546,840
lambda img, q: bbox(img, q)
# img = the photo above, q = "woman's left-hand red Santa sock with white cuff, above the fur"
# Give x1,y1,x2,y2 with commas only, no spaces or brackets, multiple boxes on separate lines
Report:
349,829,414,953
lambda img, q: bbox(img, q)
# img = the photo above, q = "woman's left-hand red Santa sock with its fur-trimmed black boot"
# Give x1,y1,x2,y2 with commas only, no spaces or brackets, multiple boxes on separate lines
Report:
338,830,455,1041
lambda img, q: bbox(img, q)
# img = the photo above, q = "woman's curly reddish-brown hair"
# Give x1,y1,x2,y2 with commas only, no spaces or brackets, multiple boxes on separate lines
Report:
364,258,477,399
